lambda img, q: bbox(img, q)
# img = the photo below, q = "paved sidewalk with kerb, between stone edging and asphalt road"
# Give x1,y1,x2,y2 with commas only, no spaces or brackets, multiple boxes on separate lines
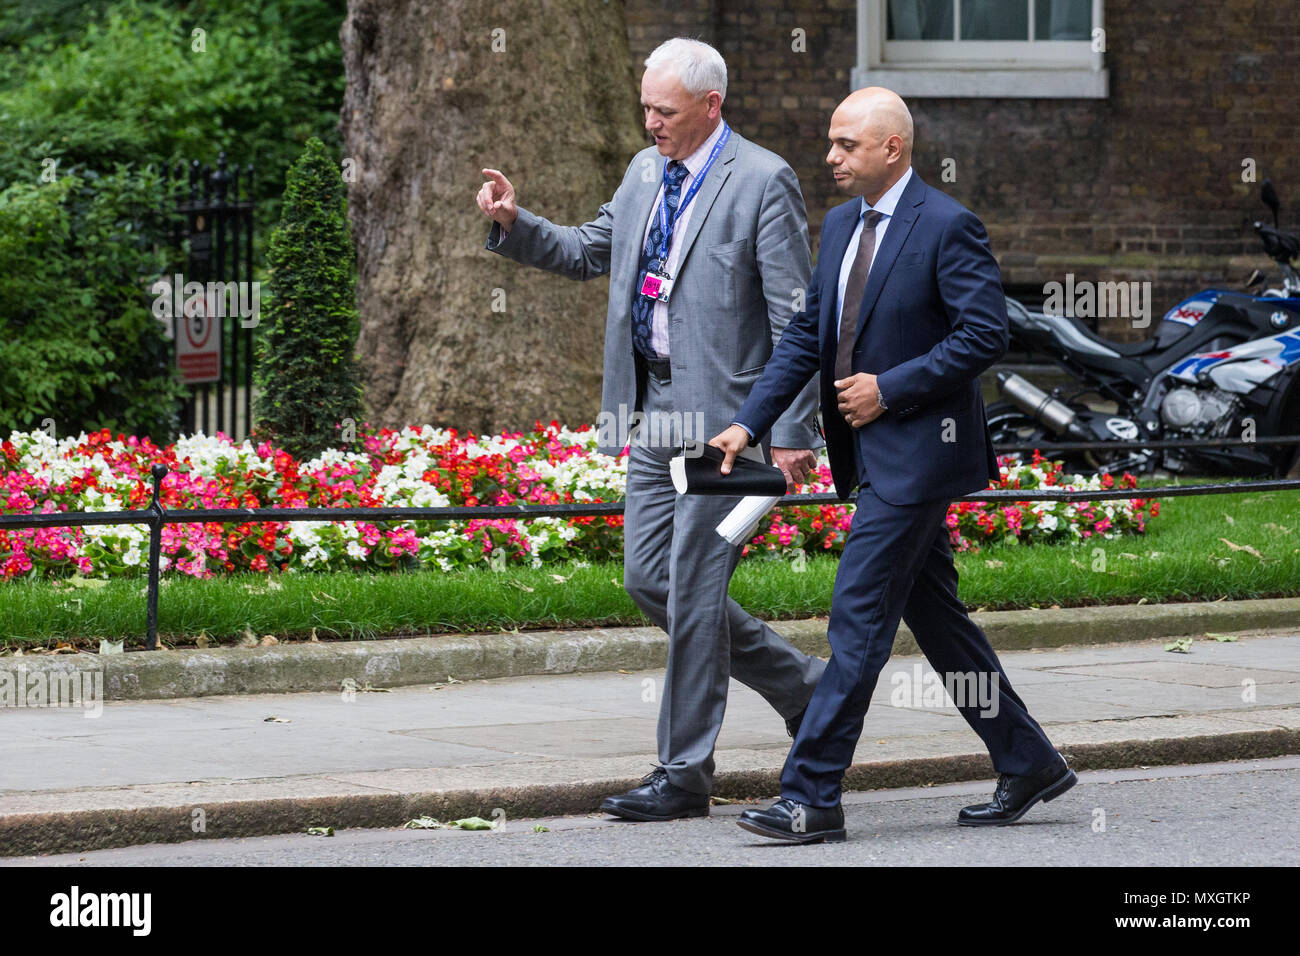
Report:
0,633,1300,855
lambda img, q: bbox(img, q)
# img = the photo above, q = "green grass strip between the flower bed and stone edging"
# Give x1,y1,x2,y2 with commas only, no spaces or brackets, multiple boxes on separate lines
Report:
0,492,1300,645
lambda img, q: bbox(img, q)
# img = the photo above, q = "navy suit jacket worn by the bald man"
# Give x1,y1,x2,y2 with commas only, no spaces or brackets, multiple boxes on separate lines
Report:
735,170,1008,505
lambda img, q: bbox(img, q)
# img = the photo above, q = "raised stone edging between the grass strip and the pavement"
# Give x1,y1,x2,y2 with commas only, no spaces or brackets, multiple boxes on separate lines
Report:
10,597,1300,701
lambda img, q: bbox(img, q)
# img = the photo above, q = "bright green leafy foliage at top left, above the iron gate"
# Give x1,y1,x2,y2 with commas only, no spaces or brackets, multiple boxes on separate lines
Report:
0,0,346,240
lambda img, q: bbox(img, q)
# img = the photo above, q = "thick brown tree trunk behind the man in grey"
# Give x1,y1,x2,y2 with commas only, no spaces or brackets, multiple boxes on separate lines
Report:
342,0,645,432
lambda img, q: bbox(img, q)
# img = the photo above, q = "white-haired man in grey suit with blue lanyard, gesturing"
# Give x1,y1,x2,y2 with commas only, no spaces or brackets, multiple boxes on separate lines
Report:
477,38,826,821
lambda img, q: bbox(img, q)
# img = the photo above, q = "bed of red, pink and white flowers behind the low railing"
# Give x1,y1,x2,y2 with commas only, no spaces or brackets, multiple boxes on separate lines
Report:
0,421,1158,579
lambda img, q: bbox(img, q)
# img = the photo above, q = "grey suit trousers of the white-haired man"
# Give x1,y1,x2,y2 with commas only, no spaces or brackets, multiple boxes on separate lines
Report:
623,375,826,793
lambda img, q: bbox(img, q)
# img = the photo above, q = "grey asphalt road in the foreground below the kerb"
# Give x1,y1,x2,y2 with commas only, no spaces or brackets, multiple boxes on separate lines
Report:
0,757,1300,866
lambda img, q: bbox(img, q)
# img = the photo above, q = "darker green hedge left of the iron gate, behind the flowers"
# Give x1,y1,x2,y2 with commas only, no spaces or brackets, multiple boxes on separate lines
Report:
0,165,182,441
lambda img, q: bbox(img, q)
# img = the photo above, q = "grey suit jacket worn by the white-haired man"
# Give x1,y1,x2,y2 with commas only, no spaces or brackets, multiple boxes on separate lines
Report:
488,130,824,455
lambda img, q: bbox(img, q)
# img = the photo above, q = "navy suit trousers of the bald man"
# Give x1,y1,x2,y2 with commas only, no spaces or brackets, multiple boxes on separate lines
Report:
781,485,1061,806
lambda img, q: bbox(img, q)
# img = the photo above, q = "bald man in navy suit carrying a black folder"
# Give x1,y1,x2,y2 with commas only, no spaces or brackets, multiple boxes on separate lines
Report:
711,87,1076,843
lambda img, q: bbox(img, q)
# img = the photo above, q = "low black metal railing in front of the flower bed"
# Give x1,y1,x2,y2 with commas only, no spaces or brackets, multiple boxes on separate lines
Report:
0,464,1300,650
